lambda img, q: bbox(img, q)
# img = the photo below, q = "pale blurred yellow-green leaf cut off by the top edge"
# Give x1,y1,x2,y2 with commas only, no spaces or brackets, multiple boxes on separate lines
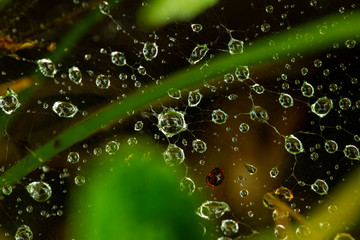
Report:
138,0,218,27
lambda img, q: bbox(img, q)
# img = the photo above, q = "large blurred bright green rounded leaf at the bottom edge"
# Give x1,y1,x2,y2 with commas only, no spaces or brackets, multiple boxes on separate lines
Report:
69,143,202,240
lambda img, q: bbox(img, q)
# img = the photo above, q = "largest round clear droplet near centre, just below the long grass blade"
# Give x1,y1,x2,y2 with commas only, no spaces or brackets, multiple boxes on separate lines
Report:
158,108,187,137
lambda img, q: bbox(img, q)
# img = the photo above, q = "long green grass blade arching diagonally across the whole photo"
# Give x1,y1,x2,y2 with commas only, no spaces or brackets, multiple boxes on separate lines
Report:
0,11,360,191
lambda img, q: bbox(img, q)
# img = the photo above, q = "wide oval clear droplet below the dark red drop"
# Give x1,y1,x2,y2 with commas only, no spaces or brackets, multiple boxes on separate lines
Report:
196,201,230,220
